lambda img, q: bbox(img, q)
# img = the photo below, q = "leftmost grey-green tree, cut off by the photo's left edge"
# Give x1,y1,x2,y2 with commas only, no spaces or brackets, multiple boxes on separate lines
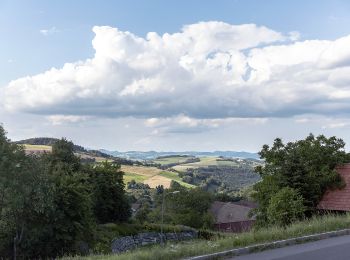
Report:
0,126,52,259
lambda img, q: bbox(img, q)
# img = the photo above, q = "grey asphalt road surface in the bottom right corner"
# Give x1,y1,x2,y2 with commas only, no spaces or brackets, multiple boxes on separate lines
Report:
231,235,350,260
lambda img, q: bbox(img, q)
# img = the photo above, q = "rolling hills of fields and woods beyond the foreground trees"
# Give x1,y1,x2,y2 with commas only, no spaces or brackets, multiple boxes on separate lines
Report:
16,137,261,192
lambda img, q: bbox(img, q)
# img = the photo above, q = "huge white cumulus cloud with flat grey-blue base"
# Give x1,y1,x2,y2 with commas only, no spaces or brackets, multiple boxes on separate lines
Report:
4,22,350,121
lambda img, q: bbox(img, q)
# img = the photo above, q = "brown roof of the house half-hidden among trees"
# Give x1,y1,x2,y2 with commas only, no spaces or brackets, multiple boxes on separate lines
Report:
210,201,254,224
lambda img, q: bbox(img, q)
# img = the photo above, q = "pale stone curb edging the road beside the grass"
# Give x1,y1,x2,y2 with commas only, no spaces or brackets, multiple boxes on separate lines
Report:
186,229,350,260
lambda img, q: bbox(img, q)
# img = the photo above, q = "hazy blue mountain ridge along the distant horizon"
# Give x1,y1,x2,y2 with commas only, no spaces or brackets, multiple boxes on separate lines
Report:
100,149,260,160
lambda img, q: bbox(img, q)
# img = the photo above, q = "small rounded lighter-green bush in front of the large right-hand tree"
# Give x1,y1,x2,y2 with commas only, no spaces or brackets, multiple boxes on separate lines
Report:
267,187,305,226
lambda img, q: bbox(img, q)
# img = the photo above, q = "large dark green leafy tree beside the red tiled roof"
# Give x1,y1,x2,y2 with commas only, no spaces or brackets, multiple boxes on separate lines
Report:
254,134,349,225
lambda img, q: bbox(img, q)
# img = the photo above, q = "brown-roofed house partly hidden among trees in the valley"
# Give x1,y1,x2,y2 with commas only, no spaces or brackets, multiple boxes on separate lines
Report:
210,201,256,232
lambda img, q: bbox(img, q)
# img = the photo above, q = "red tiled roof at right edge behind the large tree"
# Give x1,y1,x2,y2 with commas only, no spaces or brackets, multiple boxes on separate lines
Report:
317,164,350,211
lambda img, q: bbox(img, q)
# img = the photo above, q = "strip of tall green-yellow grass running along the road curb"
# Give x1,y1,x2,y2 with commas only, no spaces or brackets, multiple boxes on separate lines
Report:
65,214,350,260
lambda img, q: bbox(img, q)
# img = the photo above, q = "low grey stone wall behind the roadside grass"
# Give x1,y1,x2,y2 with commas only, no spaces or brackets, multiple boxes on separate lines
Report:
111,230,198,254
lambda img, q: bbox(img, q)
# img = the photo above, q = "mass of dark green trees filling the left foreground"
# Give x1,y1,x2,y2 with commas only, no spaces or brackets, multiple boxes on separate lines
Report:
0,127,130,258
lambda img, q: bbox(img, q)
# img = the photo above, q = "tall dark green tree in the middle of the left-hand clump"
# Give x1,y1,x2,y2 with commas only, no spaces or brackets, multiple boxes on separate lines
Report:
34,139,95,256
